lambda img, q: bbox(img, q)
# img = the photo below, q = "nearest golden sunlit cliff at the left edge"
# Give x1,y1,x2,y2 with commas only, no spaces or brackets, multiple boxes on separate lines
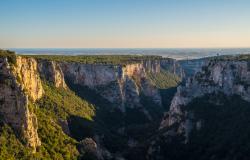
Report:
0,58,43,152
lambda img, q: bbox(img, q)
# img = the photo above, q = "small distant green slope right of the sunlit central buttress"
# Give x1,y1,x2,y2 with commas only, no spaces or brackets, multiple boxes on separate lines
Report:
147,70,181,89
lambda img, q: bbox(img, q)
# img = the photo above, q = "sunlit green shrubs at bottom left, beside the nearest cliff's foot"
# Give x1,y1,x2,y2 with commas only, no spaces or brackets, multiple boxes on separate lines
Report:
34,103,79,160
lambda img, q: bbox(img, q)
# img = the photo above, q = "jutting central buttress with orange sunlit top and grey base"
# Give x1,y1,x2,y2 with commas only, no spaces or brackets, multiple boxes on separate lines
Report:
118,61,161,107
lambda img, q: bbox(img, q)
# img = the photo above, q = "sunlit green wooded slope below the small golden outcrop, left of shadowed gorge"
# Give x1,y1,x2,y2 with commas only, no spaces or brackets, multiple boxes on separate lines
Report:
37,83,95,120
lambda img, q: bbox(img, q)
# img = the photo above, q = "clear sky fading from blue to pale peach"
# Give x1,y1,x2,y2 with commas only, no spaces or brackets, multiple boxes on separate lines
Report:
0,0,250,48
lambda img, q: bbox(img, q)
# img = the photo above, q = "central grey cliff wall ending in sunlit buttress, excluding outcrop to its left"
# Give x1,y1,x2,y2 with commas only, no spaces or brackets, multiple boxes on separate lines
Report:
60,61,164,109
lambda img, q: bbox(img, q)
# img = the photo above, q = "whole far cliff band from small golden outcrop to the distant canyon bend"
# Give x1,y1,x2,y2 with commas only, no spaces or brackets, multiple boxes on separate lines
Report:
35,59,183,110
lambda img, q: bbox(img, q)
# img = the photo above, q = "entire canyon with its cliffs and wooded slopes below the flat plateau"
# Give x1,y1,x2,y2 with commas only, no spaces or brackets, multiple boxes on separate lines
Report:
0,51,250,160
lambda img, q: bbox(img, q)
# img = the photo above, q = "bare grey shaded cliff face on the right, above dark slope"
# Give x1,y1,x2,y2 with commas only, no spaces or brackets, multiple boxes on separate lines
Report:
160,60,250,141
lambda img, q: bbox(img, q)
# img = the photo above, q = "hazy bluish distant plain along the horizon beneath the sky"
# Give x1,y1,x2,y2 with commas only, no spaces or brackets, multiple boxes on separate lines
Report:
9,48,250,60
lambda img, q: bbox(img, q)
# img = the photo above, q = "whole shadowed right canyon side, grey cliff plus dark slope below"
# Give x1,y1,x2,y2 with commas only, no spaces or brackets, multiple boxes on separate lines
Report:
148,58,250,159
